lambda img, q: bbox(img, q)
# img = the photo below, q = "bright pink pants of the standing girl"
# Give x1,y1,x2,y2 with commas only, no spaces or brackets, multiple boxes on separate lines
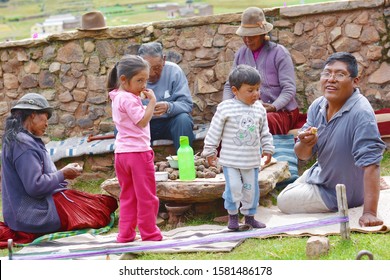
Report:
115,150,162,243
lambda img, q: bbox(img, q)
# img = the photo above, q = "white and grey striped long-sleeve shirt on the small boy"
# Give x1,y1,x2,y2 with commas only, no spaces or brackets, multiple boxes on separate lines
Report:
202,98,274,169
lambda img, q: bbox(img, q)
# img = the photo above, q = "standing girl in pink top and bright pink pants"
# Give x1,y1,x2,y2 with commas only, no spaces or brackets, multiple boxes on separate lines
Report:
107,55,162,243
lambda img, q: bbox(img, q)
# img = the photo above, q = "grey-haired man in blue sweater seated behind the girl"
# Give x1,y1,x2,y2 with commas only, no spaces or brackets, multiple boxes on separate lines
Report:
138,42,194,150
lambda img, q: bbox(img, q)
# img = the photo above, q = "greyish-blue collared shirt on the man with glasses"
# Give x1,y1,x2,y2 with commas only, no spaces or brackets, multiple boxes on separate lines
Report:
302,89,385,211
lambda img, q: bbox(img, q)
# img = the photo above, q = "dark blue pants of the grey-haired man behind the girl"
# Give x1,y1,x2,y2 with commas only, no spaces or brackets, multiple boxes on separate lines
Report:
150,113,195,151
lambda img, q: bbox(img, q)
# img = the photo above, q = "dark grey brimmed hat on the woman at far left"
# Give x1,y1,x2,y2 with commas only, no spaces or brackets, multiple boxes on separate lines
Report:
11,93,53,118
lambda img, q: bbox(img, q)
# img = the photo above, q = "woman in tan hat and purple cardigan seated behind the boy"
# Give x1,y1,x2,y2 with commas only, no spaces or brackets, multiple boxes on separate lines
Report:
223,7,299,134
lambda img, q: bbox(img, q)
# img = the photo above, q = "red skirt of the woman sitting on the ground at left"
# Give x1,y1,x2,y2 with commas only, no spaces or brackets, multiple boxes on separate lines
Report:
53,189,118,231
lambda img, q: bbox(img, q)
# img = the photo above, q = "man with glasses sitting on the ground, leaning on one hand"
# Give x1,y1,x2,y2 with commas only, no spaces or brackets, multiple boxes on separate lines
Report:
278,52,385,226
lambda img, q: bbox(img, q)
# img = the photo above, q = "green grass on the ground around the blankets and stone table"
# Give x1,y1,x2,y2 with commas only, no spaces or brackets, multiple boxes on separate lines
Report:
0,150,390,260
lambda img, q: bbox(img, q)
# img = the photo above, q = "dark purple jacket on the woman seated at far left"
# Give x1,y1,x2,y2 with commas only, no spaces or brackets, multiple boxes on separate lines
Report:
1,131,67,233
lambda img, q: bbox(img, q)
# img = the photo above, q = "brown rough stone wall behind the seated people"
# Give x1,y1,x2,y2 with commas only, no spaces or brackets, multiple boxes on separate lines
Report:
0,0,390,138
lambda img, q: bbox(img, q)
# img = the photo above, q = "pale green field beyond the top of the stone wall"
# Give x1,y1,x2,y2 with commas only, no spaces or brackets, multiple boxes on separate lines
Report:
0,0,331,42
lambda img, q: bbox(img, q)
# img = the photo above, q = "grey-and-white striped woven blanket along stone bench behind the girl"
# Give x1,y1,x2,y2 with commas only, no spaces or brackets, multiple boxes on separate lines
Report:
46,124,209,162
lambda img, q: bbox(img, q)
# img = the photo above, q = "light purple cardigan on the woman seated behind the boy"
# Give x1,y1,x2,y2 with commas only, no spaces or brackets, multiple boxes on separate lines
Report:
223,41,298,111
